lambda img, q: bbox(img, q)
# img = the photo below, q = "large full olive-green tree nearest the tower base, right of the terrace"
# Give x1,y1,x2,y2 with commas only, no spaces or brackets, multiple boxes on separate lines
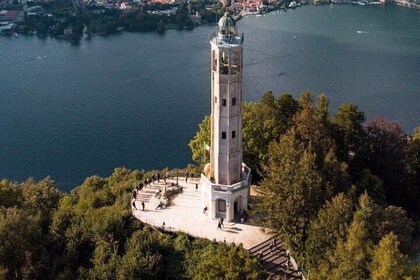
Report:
258,129,324,254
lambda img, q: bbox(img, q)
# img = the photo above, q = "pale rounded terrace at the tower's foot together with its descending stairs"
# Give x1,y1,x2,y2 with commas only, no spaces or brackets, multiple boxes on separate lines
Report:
132,178,305,280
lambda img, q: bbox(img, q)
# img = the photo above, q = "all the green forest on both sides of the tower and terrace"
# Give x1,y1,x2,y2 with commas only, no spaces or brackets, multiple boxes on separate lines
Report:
0,92,420,280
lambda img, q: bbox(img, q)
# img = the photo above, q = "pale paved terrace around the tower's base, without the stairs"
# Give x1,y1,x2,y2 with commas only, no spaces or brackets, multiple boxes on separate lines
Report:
133,179,269,249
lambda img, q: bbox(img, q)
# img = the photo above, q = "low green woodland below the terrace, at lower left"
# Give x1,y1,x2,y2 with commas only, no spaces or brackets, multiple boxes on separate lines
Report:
0,168,266,279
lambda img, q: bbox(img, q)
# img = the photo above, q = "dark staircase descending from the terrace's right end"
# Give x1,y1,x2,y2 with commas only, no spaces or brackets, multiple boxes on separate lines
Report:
248,238,304,280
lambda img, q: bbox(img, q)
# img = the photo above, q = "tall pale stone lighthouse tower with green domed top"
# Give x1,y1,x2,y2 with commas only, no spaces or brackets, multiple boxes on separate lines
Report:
201,13,251,221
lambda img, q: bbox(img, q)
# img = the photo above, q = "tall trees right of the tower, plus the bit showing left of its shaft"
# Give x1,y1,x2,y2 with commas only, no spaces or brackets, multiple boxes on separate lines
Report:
189,92,420,280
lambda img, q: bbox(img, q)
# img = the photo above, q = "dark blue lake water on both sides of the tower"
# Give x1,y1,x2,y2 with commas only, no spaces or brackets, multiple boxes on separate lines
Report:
0,5,420,191
